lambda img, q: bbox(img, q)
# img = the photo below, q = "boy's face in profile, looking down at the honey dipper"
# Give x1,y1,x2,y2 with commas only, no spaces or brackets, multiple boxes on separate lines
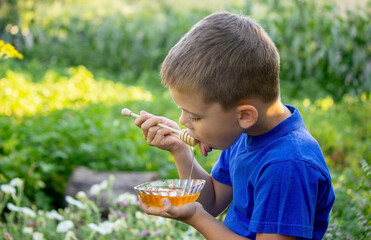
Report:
169,88,244,150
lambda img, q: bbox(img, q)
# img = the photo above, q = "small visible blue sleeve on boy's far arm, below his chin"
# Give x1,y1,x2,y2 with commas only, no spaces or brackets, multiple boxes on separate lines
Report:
211,149,232,185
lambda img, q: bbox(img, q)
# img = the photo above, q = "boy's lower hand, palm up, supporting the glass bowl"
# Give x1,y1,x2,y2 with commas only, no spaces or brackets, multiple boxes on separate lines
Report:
139,197,203,223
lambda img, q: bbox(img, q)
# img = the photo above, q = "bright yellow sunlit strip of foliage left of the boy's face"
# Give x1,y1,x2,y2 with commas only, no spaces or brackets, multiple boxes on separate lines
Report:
0,66,152,116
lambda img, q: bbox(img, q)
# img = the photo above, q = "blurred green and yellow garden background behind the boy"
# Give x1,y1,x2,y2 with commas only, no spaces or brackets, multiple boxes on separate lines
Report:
0,0,371,239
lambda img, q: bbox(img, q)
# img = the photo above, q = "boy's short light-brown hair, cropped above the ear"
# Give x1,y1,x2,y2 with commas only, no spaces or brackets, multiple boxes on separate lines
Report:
161,12,280,110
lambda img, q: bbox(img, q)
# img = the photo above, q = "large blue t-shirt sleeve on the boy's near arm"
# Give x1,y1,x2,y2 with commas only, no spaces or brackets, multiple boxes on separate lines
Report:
249,161,323,238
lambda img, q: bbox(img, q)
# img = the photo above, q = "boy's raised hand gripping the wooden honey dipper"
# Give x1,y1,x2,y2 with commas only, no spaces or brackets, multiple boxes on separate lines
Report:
134,111,186,152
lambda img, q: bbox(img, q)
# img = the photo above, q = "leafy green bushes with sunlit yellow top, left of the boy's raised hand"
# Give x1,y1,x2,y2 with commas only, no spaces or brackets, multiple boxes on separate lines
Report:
0,67,175,207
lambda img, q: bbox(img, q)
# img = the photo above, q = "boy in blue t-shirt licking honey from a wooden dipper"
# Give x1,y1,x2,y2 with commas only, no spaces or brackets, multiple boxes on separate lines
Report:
135,12,335,240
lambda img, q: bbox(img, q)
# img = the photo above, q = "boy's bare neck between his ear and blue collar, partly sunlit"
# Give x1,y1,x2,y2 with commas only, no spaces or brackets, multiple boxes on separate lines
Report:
246,99,291,136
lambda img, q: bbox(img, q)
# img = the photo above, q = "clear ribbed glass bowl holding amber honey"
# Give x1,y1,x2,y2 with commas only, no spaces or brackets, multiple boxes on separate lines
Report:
134,179,205,208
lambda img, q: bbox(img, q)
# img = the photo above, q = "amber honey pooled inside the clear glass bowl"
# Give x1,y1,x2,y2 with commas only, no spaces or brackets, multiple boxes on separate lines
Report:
138,192,200,208
